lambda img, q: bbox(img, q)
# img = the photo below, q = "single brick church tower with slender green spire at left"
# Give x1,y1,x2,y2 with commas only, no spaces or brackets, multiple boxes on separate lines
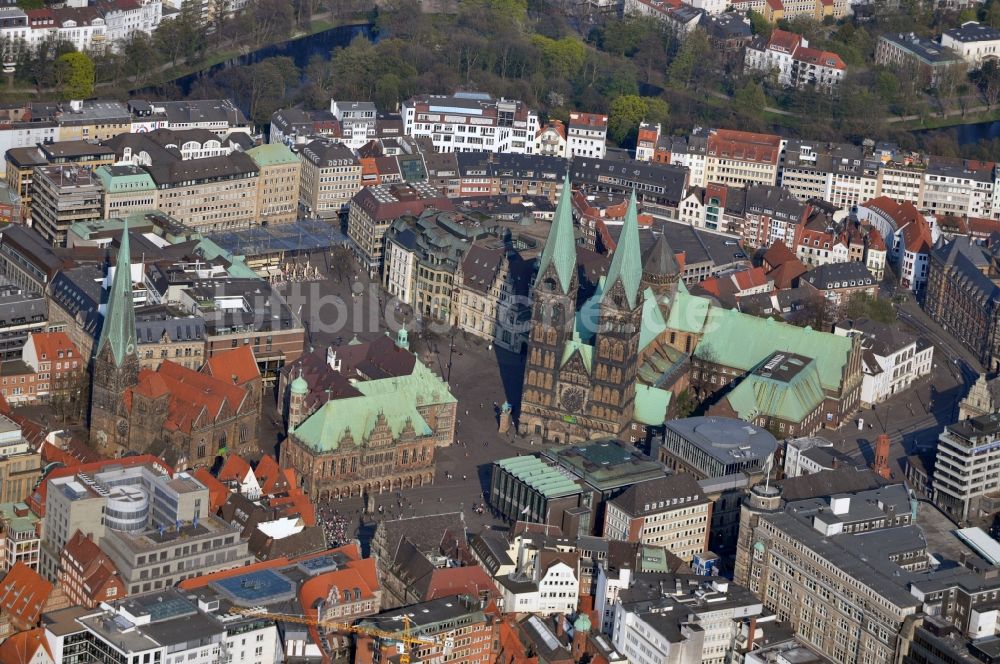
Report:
90,223,139,451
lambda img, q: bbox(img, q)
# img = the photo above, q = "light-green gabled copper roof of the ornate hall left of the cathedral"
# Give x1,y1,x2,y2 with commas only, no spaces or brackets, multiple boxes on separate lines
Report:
295,360,455,452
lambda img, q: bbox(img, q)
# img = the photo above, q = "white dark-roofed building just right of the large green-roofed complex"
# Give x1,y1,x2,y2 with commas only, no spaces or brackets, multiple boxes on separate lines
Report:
834,319,934,406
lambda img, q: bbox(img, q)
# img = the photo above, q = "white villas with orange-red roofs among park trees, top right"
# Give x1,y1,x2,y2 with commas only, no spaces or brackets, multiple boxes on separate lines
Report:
744,29,847,91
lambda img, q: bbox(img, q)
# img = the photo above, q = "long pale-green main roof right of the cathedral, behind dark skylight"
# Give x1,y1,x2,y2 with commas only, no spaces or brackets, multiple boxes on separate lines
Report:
696,307,852,391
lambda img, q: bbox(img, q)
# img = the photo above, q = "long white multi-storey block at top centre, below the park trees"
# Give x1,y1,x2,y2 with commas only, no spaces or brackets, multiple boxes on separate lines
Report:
402,92,539,154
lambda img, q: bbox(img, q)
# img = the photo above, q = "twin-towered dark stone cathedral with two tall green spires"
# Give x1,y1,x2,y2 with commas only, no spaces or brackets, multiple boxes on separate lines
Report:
518,178,686,443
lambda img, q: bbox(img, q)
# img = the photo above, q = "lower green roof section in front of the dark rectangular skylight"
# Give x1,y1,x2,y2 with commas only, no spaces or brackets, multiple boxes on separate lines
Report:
726,358,823,422
